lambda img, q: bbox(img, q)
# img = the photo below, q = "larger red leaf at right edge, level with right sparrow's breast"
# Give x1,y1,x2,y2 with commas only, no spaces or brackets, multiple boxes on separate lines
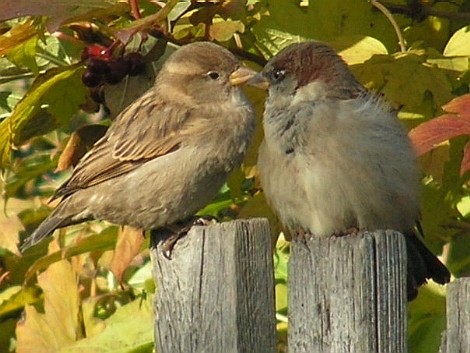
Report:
409,114,470,156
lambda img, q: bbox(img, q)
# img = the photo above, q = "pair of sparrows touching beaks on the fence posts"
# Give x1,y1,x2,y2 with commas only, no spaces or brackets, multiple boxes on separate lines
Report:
22,42,450,299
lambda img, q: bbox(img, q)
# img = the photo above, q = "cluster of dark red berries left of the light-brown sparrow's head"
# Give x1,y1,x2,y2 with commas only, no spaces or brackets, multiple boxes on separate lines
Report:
82,44,145,88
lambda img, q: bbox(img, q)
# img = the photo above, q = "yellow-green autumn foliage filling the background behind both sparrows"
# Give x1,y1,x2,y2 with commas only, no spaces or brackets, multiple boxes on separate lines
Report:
0,0,470,353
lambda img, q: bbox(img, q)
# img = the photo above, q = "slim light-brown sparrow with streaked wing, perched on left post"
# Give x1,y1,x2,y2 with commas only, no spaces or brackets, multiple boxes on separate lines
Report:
22,42,255,250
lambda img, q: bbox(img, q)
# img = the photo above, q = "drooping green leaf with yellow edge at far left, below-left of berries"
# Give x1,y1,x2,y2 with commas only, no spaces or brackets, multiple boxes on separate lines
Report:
0,66,86,168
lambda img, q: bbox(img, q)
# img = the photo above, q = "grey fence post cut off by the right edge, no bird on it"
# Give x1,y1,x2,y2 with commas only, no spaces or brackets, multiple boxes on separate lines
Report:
440,277,470,353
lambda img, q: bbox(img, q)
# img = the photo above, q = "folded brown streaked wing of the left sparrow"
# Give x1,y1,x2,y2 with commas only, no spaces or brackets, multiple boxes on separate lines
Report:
54,92,193,198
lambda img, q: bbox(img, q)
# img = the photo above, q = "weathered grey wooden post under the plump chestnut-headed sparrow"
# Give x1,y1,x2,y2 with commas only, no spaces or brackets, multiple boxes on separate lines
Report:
288,230,407,353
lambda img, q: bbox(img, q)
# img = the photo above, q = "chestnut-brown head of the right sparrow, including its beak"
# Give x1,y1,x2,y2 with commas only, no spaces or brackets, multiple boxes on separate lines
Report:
251,42,364,101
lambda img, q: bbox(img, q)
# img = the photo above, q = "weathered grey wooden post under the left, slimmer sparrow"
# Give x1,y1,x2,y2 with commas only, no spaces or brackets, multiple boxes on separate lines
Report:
152,219,276,353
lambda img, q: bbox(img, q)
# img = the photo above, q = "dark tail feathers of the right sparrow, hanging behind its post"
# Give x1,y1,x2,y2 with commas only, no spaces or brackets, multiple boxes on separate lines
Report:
405,233,450,300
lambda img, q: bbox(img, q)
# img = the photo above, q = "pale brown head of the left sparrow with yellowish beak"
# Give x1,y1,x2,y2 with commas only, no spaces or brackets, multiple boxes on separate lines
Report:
158,42,256,103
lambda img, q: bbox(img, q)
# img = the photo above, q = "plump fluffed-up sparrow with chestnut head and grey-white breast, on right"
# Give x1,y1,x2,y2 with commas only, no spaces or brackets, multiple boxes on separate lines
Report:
252,42,450,299
